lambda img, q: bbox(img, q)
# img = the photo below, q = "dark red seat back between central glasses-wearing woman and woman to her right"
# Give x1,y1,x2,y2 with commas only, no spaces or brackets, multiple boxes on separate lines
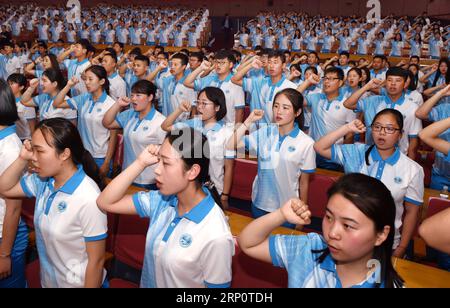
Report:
230,159,258,201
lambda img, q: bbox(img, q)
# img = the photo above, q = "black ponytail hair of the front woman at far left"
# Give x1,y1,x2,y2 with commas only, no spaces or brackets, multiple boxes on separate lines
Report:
36,118,104,190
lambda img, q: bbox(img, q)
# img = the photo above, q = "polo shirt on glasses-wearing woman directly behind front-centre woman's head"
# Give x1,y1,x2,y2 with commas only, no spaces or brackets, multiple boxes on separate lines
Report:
173,117,235,195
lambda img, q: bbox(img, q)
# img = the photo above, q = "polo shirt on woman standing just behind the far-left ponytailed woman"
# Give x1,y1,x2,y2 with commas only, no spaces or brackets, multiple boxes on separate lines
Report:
67,92,115,158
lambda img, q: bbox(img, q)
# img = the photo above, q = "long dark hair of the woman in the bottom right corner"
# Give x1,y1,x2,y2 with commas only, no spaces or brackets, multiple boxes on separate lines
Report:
314,173,404,288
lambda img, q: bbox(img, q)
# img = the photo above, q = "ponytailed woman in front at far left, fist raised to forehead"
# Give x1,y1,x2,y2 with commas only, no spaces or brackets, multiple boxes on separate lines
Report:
0,118,107,288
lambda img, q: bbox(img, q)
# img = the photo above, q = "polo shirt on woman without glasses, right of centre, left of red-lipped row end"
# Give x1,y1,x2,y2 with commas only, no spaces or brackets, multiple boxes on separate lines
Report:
244,124,316,212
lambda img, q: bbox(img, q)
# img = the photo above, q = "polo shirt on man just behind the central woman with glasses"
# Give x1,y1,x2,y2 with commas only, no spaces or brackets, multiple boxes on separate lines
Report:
194,73,245,123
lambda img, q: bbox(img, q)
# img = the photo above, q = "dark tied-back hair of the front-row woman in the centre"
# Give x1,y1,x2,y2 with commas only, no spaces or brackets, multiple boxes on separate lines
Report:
167,127,223,209
